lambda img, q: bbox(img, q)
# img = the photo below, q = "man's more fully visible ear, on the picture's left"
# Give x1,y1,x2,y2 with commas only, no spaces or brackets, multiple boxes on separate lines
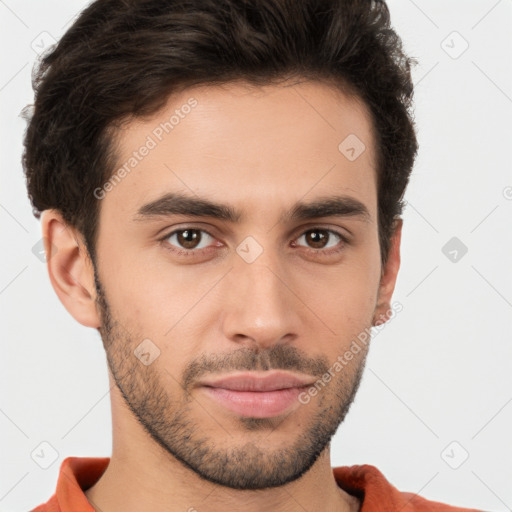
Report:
41,209,101,328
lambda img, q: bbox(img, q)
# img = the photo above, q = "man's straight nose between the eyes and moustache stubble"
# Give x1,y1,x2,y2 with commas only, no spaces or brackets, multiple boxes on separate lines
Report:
222,255,301,349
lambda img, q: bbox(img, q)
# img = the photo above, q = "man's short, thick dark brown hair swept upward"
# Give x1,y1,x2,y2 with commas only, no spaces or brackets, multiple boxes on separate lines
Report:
23,0,418,270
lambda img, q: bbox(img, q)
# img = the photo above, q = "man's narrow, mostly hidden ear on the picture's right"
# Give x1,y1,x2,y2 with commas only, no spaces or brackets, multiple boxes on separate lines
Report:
372,219,403,326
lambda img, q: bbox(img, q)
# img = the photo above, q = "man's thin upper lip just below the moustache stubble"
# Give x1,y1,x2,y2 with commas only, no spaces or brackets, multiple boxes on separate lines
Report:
199,371,314,391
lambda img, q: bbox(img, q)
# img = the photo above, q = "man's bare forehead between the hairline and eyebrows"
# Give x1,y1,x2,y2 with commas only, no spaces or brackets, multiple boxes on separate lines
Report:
101,81,377,222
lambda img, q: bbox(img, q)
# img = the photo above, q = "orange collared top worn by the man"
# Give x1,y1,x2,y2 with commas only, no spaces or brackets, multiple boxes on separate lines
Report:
31,457,481,512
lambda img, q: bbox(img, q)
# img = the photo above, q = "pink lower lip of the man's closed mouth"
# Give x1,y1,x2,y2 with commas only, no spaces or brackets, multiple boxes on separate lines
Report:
203,386,307,418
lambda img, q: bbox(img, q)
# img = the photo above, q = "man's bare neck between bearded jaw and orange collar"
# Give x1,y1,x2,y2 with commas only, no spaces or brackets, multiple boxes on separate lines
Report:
85,437,360,512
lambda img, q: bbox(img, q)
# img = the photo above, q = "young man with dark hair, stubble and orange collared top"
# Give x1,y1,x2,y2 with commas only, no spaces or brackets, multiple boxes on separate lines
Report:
24,0,484,512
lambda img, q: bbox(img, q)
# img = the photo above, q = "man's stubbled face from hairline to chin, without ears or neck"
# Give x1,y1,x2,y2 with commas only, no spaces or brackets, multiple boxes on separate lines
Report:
90,82,392,489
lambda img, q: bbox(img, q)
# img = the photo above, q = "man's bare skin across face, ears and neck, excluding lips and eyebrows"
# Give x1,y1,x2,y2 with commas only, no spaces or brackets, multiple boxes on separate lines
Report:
42,77,402,512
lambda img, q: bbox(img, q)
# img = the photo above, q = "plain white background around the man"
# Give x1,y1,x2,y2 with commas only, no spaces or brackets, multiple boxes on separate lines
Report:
0,0,512,512
